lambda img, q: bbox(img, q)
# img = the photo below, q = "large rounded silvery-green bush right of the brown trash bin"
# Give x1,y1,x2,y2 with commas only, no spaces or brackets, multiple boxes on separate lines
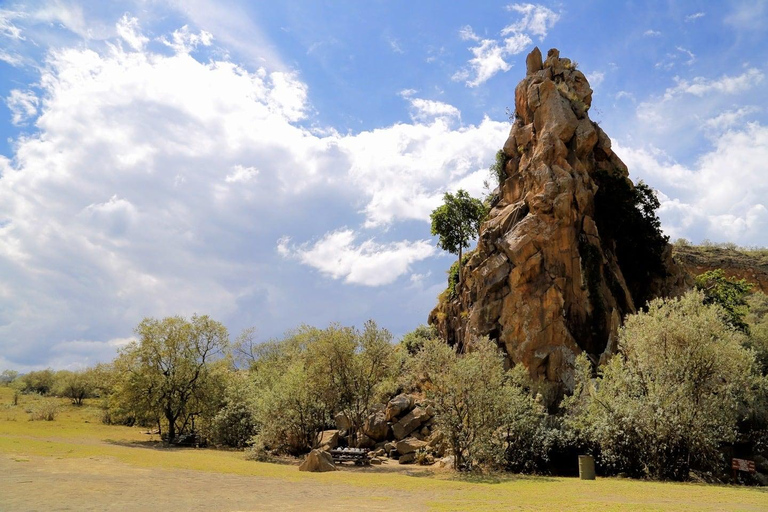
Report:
564,291,756,480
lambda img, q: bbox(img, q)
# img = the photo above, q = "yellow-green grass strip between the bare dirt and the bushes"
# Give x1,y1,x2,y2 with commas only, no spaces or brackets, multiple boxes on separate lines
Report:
0,388,768,511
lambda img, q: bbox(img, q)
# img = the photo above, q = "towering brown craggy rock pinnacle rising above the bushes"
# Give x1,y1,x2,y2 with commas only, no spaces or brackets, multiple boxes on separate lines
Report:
429,48,684,386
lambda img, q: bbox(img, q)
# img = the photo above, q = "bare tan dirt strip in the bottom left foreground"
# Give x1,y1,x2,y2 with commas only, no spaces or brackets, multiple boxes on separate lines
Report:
0,455,435,512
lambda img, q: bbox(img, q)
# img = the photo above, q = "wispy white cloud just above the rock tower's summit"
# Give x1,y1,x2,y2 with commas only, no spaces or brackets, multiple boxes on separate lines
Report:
453,3,560,87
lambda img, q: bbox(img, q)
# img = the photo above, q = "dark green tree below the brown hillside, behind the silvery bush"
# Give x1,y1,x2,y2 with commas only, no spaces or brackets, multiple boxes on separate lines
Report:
696,268,752,332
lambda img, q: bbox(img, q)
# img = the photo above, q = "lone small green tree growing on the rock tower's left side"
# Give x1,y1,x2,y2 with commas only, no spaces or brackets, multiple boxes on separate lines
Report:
429,189,487,283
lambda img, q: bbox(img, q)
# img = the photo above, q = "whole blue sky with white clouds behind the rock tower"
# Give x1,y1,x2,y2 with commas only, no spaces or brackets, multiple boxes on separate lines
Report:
0,0,768,371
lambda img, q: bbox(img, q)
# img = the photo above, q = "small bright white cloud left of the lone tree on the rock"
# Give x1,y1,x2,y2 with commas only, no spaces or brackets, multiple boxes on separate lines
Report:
277,229,436,286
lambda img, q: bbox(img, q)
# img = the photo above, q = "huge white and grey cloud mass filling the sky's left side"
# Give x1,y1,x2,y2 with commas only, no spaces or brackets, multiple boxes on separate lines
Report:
0,18,509,368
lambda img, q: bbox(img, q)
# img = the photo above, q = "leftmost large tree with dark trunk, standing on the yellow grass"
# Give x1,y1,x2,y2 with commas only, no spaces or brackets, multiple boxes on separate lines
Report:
115,315,228,442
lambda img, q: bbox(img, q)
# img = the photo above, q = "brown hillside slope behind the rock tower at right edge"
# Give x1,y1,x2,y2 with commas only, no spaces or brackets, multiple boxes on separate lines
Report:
672,241,768,293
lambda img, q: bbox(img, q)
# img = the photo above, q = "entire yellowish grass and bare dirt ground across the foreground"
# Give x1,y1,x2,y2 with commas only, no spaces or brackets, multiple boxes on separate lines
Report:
0,388,768,511
